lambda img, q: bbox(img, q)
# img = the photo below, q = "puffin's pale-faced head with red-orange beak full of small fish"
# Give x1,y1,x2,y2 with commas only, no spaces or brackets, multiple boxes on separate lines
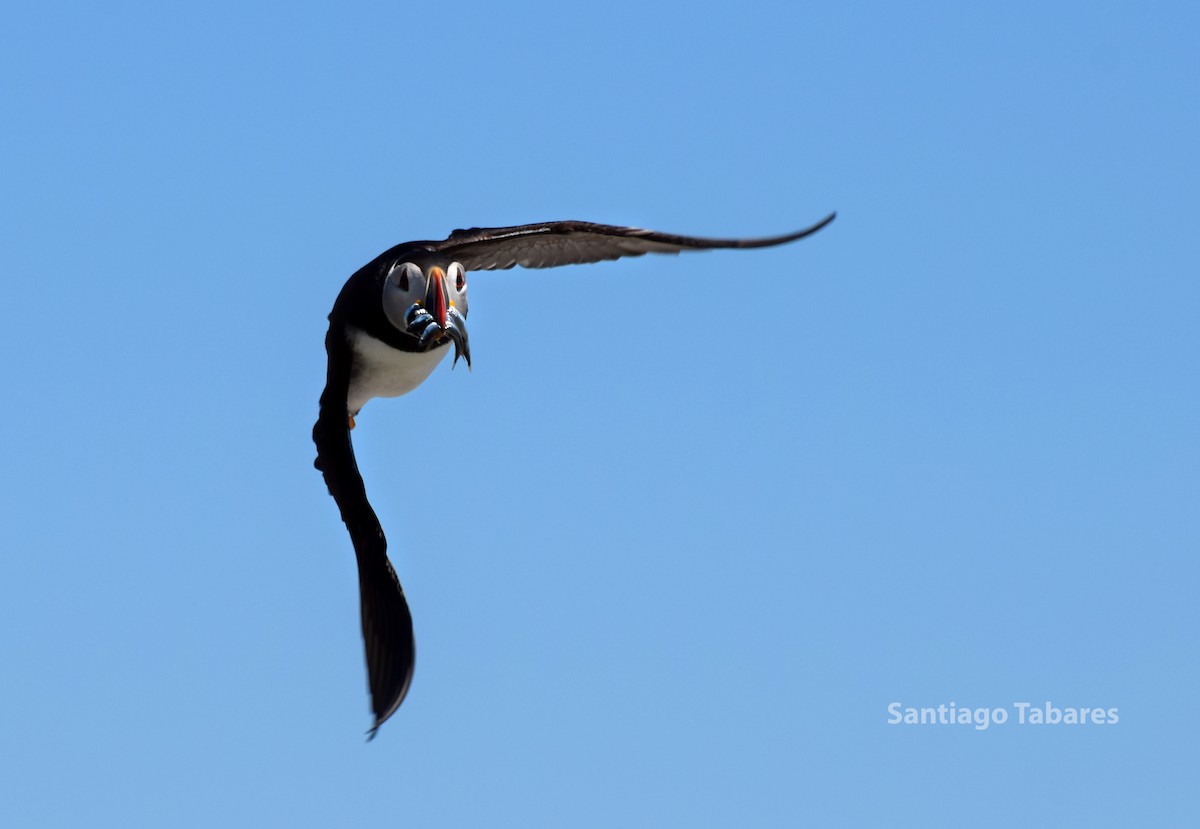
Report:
383,252,470,367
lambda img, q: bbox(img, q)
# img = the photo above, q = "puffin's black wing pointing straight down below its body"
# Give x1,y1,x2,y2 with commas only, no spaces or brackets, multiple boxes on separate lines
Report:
312,324,416,737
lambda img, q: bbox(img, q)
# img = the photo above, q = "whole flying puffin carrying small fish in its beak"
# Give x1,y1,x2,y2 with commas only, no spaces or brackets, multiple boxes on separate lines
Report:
312,214,834,737
